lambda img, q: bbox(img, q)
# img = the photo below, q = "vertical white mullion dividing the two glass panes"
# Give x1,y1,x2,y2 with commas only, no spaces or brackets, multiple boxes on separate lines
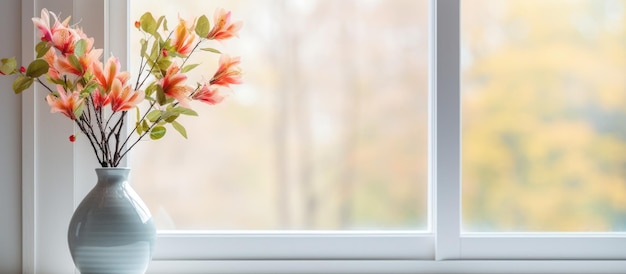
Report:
431,0,461,260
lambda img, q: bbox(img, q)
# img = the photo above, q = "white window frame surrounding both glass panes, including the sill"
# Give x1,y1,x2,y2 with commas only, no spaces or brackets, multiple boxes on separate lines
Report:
21,0,626,273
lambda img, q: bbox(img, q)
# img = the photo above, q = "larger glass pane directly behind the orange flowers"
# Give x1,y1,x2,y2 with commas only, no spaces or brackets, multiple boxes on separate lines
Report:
130,0,429,230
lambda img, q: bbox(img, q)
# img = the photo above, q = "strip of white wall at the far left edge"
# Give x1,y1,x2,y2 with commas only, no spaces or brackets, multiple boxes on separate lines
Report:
0,0,22,274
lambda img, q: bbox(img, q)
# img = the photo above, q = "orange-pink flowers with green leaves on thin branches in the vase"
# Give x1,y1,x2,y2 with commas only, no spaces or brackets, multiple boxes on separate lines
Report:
0,8,242,167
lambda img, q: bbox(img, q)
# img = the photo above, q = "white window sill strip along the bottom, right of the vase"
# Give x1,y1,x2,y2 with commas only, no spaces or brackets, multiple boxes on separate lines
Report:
147,260,626,274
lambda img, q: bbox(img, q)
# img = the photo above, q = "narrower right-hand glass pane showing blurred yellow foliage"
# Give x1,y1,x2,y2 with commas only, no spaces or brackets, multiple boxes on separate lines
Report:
461,0,626,232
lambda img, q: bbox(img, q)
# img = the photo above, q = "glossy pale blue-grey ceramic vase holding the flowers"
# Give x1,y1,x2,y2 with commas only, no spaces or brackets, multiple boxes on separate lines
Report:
67,168,156,274
